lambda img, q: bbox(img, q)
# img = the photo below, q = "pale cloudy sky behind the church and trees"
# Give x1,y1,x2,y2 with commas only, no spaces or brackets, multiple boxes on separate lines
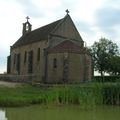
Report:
0,0,120,73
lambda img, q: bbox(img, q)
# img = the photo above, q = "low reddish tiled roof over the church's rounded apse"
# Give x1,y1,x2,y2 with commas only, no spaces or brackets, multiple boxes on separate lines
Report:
48,40,86,53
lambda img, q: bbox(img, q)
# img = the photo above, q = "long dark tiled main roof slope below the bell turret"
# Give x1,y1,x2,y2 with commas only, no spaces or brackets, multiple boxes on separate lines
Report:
12,19,62,48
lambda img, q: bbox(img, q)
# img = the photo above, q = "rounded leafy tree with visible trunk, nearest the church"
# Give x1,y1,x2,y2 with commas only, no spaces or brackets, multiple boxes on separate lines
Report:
90,38,118,76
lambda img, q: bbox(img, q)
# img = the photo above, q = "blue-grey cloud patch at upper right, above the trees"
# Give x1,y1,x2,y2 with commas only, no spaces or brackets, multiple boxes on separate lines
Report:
95,6,120,38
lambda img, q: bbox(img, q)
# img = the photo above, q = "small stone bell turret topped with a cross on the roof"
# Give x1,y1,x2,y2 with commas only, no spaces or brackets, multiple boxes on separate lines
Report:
22,16,32,35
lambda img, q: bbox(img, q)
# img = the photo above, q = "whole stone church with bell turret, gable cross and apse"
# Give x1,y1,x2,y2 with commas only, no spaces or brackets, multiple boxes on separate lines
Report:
7,11,93,83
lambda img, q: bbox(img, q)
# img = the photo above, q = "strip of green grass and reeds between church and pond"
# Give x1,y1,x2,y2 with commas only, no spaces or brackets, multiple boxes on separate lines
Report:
0,83,120,107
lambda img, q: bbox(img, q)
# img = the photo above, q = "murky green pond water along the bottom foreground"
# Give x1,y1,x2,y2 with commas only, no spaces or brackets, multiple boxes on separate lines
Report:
0,105,120,120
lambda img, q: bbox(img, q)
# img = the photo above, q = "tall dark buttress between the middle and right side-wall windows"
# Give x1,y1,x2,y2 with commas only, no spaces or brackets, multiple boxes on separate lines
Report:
28,51,33,73
